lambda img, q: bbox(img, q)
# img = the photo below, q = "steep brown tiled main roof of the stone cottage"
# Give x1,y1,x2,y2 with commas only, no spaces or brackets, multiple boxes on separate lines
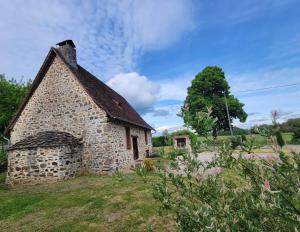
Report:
5,48,154,134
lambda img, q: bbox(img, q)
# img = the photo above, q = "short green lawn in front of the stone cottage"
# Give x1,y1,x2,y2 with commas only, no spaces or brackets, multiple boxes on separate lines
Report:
0,173,175,231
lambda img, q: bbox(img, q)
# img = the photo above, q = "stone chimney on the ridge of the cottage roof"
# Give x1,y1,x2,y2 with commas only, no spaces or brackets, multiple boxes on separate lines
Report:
56,39,77,68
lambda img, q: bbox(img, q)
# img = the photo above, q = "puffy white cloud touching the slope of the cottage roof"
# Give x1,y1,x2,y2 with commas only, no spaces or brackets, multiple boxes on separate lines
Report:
107,72,160,114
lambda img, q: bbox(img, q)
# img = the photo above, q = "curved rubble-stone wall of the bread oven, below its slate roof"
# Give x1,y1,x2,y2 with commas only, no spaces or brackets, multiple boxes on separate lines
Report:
6,146,82,185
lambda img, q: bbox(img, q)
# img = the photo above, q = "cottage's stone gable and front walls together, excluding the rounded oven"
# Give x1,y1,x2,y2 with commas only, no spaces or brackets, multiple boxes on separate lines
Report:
11,54,151,173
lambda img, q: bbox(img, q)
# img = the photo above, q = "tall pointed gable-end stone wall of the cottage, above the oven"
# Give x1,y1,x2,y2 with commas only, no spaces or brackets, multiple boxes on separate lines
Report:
11,57,111,172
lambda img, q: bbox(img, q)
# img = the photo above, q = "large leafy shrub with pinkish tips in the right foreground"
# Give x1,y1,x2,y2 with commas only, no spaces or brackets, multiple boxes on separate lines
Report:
154,109,300,231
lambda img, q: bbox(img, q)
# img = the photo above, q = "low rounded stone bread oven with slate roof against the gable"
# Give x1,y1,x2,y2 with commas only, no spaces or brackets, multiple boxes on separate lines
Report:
6,131,82,185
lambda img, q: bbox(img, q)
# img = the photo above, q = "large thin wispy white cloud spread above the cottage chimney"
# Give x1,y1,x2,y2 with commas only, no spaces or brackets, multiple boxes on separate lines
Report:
0,0,193,80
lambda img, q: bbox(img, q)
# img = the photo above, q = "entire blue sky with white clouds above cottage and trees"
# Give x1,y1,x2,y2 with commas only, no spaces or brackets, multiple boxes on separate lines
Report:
0,0,300,134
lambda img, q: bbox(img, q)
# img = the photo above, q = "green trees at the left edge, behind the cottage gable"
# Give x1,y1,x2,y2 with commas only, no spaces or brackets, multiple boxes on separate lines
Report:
0,74,31,135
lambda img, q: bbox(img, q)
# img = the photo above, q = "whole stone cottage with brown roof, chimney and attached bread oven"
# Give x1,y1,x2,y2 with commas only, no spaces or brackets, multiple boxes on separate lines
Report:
6,40,153,184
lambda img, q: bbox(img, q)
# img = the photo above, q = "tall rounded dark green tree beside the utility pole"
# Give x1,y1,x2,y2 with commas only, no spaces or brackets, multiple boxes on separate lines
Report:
180,66,248,136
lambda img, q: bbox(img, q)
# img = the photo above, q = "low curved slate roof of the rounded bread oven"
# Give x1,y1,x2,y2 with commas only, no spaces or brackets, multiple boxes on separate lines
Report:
8,131,82,150
